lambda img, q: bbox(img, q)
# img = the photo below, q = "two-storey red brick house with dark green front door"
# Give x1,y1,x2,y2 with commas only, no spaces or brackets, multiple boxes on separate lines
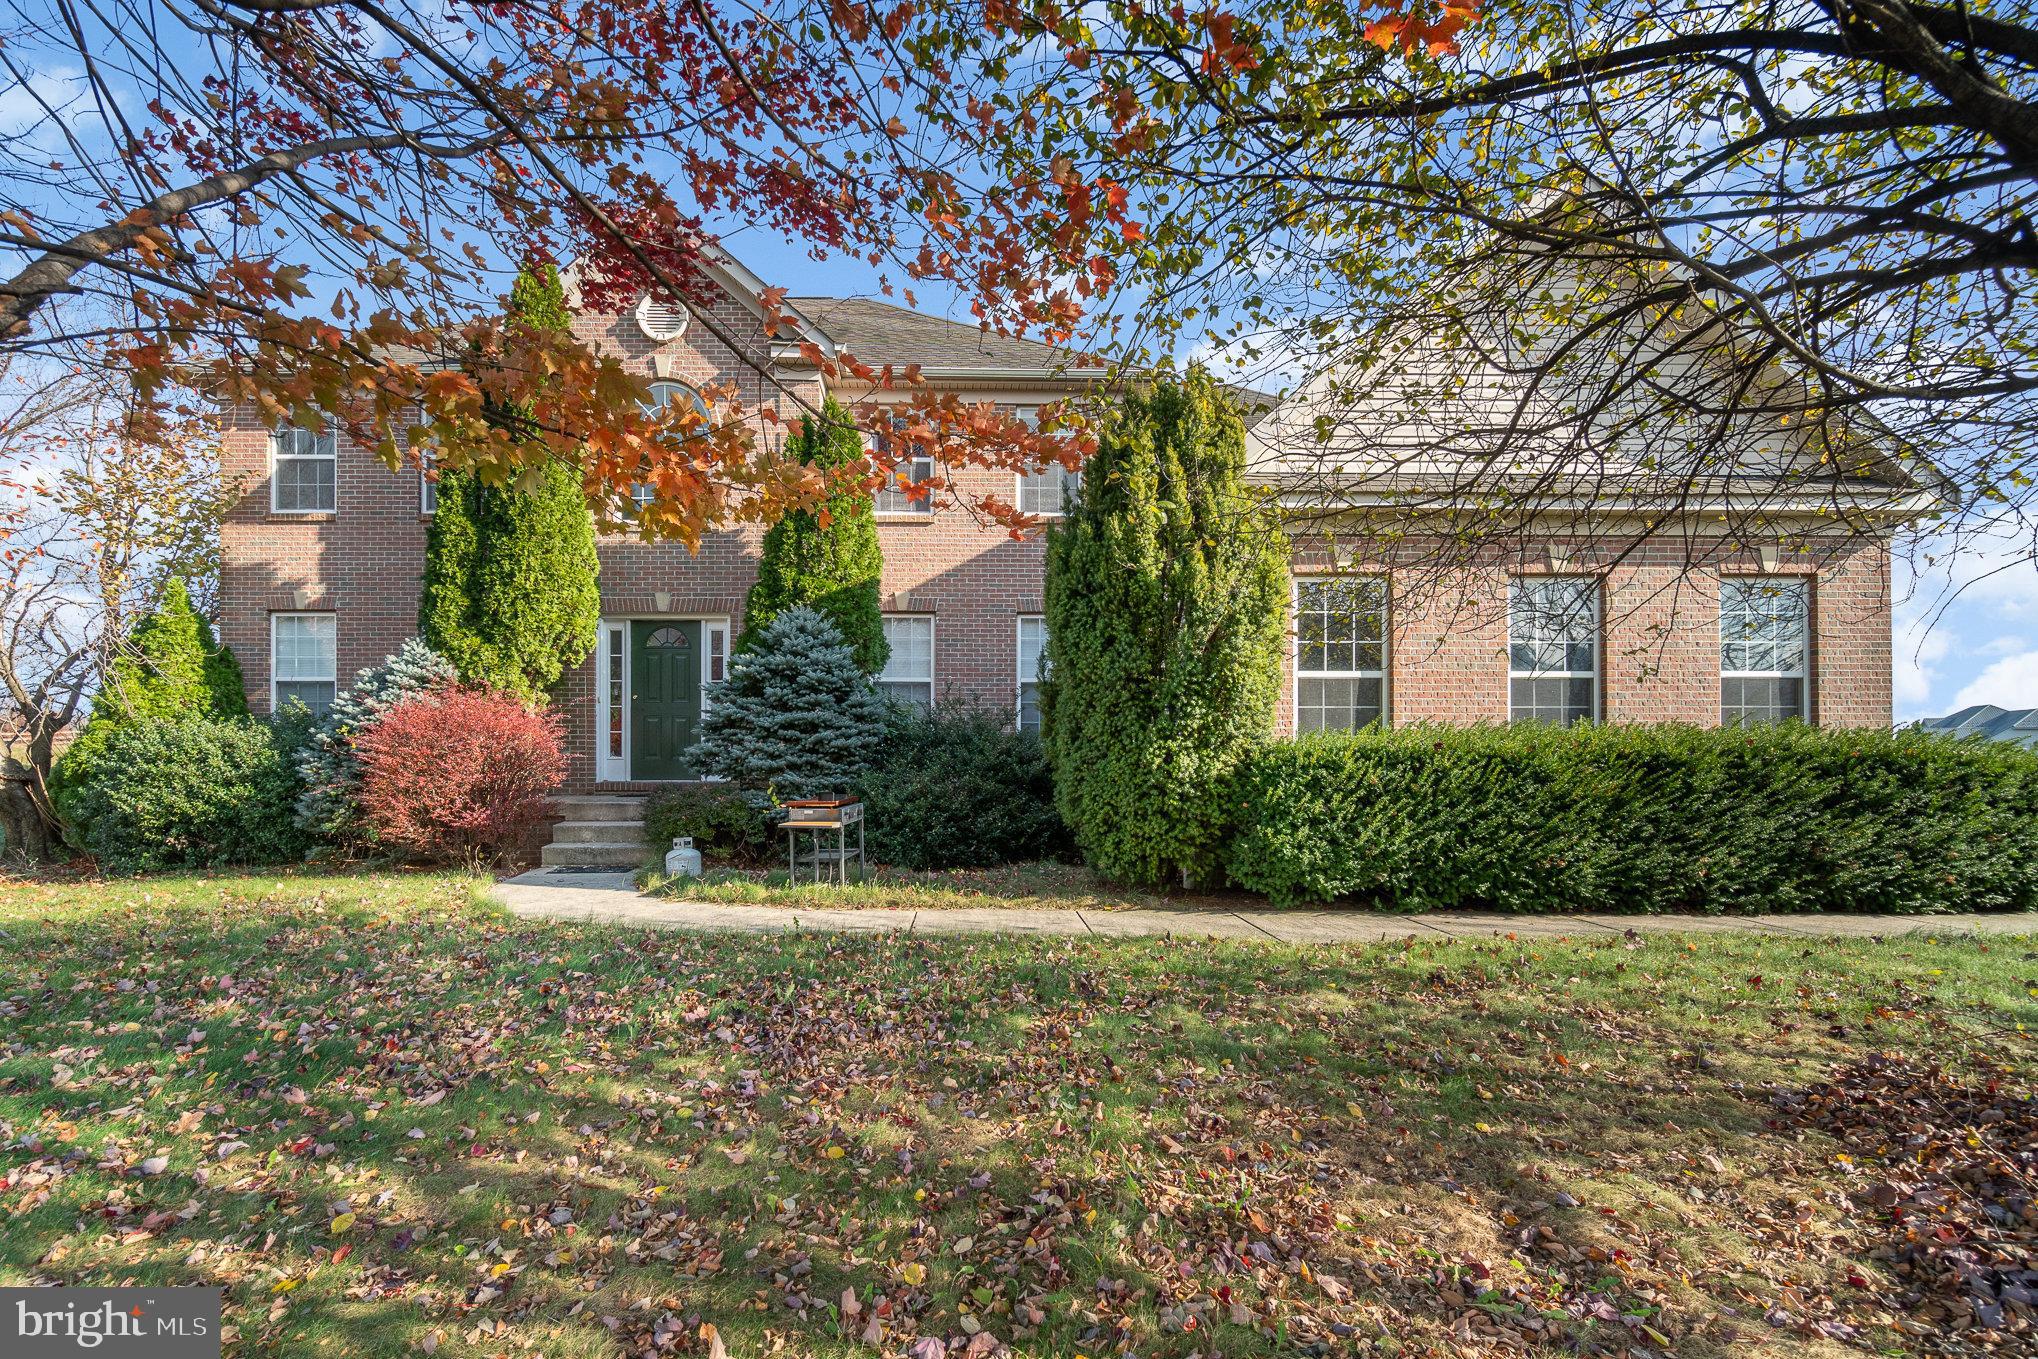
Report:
220,252,1924,793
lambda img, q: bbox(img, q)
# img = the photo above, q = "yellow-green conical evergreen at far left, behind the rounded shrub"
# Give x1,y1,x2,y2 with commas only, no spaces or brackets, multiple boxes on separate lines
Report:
49,577,249,841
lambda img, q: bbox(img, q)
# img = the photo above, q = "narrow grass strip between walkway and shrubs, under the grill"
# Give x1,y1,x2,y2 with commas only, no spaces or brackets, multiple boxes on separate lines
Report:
638,864,1268,911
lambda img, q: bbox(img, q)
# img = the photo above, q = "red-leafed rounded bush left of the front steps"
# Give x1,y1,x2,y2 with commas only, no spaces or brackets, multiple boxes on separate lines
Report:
355,689,567,864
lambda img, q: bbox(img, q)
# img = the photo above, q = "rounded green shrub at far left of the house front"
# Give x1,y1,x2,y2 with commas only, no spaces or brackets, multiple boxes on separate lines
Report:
77,717,308,872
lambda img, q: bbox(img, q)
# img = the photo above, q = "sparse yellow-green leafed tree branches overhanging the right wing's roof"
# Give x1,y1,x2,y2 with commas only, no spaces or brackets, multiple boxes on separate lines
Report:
961,0,2038,590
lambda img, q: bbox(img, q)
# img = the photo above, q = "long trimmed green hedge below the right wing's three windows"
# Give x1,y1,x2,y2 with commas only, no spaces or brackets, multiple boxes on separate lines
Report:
1227,723,2038,915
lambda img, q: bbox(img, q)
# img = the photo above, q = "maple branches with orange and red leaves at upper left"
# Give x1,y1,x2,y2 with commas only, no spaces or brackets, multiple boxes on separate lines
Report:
0,0,1131,542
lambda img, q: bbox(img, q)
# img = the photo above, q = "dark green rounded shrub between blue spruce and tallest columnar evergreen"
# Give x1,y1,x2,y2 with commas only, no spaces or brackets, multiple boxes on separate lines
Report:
860,709,1074,870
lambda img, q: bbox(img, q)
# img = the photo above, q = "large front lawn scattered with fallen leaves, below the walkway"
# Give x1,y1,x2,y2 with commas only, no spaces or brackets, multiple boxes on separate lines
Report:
0,876,2038,1359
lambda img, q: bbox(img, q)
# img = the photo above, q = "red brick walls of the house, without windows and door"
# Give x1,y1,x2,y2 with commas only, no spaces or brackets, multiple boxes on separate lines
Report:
220,289,1891,789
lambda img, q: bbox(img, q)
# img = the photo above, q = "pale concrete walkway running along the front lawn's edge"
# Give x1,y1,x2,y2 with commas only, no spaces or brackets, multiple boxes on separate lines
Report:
493,872,2038,943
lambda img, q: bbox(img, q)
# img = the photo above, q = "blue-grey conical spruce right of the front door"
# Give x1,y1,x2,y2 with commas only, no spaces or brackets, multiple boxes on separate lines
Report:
699,605,884,799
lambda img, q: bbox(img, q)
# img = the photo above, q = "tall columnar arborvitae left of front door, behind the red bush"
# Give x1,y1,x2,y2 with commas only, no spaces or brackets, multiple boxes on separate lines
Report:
418,265,601,699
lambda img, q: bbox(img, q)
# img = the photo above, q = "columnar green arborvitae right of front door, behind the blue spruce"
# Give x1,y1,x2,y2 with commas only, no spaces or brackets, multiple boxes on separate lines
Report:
736,397,889,674
